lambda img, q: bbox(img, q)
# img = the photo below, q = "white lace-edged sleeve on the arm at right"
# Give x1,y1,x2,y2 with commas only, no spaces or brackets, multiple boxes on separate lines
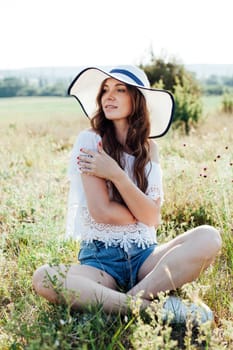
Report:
146,162,164,204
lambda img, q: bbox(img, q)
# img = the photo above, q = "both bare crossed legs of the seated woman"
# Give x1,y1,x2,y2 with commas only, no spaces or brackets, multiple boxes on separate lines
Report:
33,226,221,313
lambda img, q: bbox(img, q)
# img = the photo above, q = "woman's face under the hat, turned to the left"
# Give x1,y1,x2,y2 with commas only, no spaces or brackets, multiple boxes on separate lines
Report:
101,78,132,121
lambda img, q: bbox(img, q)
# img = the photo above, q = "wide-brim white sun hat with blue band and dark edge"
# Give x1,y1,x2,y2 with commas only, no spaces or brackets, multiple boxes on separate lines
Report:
68,66,174,138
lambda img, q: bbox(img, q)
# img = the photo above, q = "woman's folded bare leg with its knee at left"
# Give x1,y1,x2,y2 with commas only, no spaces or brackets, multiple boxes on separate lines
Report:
33,264,149,313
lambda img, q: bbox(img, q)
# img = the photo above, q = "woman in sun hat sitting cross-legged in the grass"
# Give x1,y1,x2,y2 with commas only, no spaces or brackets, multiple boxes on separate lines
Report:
33,66,221,322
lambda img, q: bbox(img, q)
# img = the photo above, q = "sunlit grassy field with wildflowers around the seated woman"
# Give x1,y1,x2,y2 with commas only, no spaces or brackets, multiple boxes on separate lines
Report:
0,94,233,350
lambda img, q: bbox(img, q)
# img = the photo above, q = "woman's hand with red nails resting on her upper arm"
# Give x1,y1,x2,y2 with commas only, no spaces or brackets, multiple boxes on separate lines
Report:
77,142,122,181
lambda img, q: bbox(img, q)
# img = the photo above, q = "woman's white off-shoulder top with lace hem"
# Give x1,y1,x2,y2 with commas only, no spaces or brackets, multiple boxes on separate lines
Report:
66,130,163,251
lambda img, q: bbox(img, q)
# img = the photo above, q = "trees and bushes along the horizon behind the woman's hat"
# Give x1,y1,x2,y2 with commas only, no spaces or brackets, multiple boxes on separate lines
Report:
0,53,233,134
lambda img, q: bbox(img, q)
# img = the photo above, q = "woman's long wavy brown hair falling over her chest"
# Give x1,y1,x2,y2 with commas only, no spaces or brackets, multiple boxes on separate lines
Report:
91,81,150,202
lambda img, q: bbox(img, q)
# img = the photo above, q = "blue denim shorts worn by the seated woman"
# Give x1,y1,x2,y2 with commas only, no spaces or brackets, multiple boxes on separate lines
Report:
78,240,157,292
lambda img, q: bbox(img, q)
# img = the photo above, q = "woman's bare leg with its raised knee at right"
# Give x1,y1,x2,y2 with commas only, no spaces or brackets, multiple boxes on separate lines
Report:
127,225,221,300
